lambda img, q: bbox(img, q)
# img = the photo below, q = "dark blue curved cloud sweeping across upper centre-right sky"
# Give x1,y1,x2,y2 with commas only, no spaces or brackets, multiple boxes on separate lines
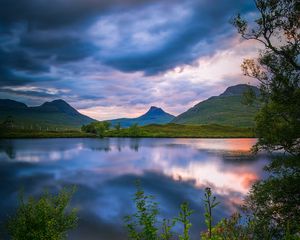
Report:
104,0,253,75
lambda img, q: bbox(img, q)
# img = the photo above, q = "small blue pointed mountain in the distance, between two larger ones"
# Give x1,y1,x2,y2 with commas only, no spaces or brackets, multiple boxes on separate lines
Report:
108,106,175,128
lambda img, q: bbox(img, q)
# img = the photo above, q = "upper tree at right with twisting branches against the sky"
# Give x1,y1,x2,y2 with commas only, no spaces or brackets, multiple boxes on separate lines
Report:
233,0,300,155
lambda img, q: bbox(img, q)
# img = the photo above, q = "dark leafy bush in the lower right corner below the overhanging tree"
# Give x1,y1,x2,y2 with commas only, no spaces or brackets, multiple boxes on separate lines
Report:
244,157,300,239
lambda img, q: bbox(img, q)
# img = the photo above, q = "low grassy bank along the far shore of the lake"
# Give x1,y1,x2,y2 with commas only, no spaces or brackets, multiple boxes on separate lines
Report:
0,124,255,138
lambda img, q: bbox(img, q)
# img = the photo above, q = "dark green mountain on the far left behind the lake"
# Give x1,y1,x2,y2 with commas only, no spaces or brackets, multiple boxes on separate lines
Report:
0,99,96,129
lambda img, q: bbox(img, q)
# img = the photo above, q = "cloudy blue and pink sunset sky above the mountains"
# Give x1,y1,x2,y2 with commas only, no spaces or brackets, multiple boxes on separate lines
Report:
0,0,258,120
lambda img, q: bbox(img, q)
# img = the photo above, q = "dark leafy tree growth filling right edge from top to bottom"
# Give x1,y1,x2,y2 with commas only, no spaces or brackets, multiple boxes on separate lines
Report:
233,0,300,239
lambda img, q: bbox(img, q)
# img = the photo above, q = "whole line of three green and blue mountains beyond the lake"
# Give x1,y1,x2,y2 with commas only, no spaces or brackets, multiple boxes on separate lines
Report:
0,84,260,129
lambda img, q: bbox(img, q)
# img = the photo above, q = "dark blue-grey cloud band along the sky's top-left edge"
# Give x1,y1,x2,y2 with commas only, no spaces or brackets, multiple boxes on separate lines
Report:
0,0,162,28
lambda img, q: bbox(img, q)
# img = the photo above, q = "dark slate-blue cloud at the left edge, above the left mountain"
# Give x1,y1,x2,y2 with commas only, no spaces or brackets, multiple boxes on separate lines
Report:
0,25,95,86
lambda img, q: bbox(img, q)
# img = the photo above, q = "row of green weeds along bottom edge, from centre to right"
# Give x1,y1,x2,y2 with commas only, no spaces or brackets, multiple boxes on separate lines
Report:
125,182,270,240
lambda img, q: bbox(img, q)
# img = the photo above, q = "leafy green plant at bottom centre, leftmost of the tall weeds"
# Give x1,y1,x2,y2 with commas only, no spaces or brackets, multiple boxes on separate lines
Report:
125,182,158,240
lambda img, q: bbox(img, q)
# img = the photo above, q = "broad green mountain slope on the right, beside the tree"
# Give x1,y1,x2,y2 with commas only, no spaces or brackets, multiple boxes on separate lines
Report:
172,84,260,127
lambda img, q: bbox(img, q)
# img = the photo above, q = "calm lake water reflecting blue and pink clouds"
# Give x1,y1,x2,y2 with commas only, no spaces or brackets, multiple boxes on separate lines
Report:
0,138,269,240
